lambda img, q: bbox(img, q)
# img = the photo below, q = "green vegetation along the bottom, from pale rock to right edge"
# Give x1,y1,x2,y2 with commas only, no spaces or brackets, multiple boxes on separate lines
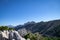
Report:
24,33,60,40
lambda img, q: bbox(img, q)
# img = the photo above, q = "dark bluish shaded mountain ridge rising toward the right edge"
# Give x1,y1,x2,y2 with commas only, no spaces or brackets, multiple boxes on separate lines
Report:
15,20,60,37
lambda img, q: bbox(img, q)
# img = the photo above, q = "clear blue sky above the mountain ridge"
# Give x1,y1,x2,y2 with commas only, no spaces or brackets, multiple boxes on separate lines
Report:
0,0,60,25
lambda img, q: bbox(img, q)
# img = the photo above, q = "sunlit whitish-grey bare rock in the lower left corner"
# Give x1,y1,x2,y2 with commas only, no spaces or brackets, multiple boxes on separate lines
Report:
0,30,25,40
